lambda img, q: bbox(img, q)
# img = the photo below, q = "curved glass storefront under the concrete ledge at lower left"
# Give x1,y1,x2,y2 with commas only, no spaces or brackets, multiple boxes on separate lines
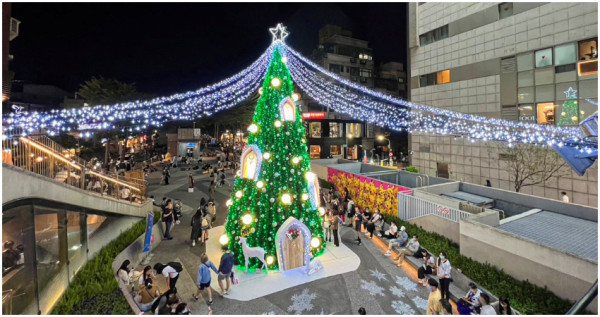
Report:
2,200,140,315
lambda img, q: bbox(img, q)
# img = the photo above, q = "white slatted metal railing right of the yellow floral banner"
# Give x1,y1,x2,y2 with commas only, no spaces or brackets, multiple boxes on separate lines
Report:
398,192,471,222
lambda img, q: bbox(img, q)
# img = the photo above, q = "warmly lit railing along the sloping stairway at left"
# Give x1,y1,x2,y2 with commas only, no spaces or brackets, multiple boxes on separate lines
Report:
2,135,146,203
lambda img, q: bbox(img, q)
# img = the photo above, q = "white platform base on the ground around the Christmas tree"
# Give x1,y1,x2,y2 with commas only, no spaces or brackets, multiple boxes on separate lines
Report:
206,226,360,301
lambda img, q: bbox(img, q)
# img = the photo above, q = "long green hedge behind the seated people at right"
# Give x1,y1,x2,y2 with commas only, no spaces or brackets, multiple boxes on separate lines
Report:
384,215,576,315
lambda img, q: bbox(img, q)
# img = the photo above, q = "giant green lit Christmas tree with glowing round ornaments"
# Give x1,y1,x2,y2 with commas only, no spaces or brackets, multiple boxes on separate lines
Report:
224,46,325,269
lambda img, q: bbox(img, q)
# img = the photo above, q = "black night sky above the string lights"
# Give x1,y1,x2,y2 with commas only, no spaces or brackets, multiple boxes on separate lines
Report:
10,3,406,95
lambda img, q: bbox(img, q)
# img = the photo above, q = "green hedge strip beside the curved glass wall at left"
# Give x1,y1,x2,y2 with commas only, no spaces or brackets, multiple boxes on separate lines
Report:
52,212,160,315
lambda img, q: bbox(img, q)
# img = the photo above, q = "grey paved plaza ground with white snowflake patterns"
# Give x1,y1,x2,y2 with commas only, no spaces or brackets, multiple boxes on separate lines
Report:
143,160,428,315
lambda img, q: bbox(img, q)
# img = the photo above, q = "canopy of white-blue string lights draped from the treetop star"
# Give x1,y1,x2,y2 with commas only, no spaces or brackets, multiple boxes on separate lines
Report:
2,23,598,153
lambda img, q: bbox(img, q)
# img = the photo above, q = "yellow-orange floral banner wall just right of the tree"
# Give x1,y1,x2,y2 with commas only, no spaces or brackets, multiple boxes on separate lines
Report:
327,168,412,215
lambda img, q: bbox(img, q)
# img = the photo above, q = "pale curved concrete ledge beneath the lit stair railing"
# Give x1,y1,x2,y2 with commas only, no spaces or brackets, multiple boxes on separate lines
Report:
2,163,152,218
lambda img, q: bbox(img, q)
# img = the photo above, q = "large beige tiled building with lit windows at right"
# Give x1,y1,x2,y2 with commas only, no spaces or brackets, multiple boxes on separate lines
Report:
409,2,598,206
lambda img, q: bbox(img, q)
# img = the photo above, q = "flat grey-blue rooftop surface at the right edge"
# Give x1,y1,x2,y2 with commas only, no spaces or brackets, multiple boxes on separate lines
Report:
498,211,598,261
